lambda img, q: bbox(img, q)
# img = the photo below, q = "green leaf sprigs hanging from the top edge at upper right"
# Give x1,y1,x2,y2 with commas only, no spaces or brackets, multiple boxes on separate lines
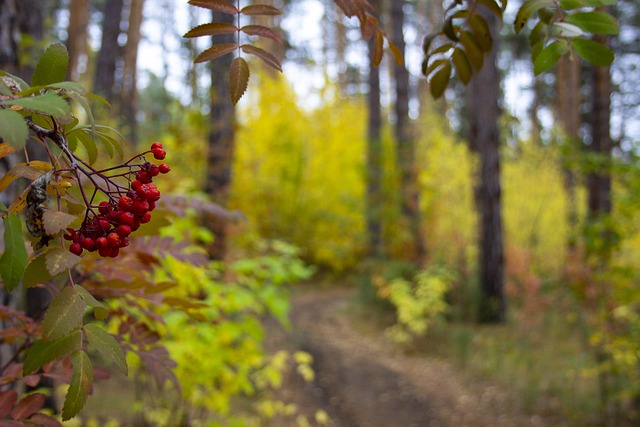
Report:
422,0,619,98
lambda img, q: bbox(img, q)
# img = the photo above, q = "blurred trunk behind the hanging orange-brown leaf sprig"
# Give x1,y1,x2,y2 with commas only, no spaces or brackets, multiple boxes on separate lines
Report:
205,12,236,259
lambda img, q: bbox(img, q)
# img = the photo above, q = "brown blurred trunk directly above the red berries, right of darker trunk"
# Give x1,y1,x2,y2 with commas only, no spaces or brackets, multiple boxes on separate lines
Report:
120,0,144,144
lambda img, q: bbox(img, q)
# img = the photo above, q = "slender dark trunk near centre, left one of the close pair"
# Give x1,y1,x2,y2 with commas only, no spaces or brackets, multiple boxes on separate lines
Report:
366,0,384,258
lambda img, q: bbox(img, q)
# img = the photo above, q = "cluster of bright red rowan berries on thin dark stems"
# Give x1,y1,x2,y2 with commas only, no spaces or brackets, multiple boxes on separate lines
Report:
64,142,171,258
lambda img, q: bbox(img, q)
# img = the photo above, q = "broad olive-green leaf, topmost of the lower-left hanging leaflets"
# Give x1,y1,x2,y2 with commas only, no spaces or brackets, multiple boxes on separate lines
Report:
42,286,87,340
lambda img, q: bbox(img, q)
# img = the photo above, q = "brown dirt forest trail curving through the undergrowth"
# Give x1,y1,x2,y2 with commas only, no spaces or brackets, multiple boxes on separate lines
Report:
272,289,566,427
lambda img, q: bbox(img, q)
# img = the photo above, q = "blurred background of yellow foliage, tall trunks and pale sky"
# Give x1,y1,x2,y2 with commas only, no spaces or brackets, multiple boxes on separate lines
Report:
0,0,640,424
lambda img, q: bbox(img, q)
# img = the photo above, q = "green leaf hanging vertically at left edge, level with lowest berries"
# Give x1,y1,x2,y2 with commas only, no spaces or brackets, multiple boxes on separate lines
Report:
0,215,28,292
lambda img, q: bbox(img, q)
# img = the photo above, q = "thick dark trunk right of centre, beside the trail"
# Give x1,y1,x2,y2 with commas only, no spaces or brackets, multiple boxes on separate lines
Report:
467,13,506,322
